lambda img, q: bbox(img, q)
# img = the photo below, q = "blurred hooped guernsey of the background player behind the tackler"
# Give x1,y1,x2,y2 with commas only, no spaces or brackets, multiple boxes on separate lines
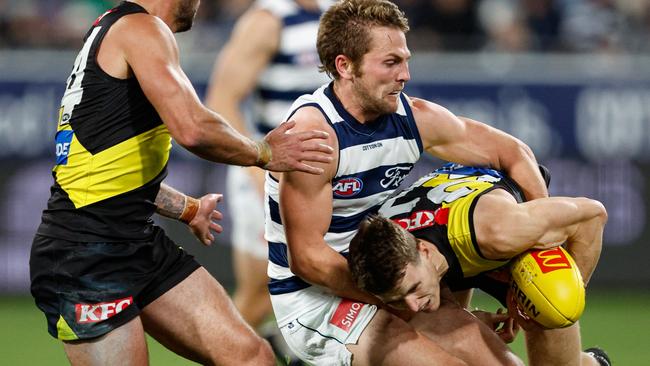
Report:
253,0,334,135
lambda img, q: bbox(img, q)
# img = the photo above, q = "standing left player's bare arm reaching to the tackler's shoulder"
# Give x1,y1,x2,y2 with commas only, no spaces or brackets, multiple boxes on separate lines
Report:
107,14,331,174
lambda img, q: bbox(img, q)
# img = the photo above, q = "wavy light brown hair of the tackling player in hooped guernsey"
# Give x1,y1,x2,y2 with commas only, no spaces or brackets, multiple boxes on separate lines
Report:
316,0,409,79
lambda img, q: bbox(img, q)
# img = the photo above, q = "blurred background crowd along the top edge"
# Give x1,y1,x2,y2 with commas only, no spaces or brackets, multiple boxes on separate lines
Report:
0,0,650,53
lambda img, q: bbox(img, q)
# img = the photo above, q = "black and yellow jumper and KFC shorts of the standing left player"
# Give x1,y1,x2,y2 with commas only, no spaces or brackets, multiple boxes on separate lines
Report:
31,3,199,340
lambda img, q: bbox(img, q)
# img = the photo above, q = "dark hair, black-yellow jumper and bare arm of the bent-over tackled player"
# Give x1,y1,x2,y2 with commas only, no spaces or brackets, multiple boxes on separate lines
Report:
349,164,606,307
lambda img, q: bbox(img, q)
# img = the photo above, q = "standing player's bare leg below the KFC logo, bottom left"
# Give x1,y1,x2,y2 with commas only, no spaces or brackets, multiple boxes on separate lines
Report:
63,317,149,366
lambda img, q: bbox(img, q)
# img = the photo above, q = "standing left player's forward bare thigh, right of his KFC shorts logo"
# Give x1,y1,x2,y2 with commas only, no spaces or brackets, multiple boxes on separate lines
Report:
141,268,275,366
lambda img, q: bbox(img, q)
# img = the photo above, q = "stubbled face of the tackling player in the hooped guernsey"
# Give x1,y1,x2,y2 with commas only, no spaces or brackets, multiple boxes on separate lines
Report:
353,27,411,116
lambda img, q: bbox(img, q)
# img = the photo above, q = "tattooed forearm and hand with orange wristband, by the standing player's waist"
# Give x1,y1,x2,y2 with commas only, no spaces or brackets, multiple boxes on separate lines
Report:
155,183,223,245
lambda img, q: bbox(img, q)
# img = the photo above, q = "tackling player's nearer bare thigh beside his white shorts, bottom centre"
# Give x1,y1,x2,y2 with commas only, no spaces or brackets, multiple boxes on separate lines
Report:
347,309,467,366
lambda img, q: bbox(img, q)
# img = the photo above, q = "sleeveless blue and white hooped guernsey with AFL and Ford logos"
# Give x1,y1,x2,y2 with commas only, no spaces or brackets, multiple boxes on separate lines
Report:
265,83,423,325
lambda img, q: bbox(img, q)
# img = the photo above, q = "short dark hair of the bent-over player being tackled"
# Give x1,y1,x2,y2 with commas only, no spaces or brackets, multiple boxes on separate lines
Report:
348,215,420,295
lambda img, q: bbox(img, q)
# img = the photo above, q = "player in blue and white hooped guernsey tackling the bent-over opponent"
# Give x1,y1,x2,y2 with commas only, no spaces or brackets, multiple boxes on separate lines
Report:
266,0,547,365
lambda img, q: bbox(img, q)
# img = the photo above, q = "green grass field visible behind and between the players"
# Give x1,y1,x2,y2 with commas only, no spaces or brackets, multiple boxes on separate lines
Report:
0,291,650,366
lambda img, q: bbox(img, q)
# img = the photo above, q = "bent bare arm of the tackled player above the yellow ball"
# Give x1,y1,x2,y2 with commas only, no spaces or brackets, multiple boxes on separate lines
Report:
474,190,607,284
